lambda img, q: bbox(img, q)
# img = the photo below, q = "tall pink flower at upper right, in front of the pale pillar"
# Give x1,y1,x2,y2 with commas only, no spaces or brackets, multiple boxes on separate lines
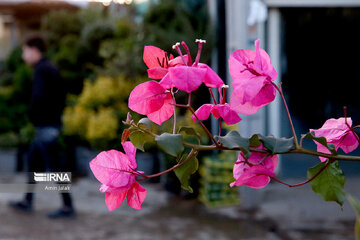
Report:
229,40,277,114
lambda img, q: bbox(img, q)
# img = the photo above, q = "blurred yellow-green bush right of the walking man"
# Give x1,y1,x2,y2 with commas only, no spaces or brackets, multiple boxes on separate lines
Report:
63,76,135,149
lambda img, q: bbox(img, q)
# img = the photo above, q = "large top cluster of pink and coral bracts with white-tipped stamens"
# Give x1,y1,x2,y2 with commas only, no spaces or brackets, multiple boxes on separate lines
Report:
129,40,228,125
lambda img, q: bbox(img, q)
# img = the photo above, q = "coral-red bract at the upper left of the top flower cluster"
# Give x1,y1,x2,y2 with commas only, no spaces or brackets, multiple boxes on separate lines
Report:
143,46,187,79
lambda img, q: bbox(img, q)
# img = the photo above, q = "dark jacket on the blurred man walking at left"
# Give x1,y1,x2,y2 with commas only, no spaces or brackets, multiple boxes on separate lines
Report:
29,58,65,126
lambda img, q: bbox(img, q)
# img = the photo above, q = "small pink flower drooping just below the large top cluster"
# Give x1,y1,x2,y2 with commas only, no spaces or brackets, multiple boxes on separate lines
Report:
191,103,241,125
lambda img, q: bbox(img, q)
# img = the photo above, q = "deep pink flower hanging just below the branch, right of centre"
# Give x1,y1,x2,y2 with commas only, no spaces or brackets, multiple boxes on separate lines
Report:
230,145,278,188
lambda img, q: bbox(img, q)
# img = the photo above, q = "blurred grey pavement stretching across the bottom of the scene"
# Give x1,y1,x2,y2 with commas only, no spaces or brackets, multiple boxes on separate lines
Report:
0,175,360,240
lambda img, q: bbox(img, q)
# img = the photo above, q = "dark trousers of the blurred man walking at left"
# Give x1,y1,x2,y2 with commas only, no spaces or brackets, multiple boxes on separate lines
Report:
25,126,72,208
